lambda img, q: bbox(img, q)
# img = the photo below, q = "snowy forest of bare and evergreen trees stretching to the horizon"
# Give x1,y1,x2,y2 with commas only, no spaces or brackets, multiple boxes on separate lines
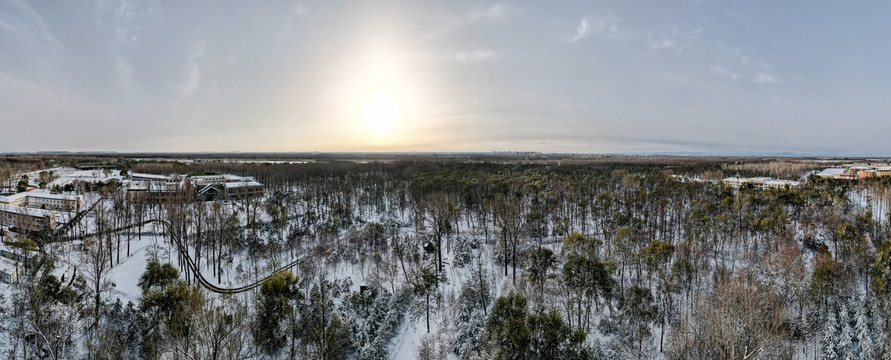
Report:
0,157,891,360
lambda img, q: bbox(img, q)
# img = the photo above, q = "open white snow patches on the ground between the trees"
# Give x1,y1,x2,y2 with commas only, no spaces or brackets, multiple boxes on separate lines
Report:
0,163,888,359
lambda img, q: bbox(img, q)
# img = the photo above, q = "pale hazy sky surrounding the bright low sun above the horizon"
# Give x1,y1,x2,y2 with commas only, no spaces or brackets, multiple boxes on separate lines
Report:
0,0,891,155
